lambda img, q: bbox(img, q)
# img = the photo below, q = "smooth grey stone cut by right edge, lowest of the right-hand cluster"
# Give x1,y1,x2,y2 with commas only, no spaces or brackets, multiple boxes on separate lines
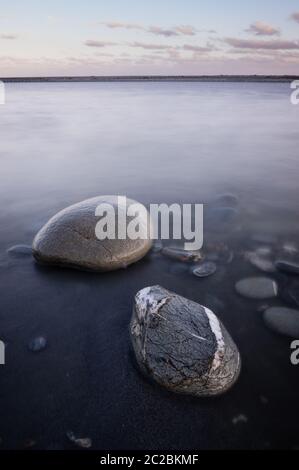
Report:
264,307,299,339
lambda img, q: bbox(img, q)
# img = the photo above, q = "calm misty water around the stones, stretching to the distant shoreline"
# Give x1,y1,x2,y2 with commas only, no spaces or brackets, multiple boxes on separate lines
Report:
0,83,299,449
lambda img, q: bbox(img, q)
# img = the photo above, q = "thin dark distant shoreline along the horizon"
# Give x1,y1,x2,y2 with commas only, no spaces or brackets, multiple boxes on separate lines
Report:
0,75,299,83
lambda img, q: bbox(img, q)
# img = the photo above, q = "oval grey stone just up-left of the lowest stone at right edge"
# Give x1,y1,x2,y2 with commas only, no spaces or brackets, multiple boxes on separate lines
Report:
235,277,278,300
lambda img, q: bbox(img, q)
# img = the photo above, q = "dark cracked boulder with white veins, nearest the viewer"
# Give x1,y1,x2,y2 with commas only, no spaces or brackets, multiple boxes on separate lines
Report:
130,286,241,397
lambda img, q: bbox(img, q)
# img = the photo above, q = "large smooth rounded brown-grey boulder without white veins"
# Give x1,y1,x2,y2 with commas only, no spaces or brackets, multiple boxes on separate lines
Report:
32,196,152,271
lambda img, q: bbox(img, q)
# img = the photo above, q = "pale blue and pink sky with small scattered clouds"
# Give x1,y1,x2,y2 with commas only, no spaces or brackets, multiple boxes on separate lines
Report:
0,0,299,77
